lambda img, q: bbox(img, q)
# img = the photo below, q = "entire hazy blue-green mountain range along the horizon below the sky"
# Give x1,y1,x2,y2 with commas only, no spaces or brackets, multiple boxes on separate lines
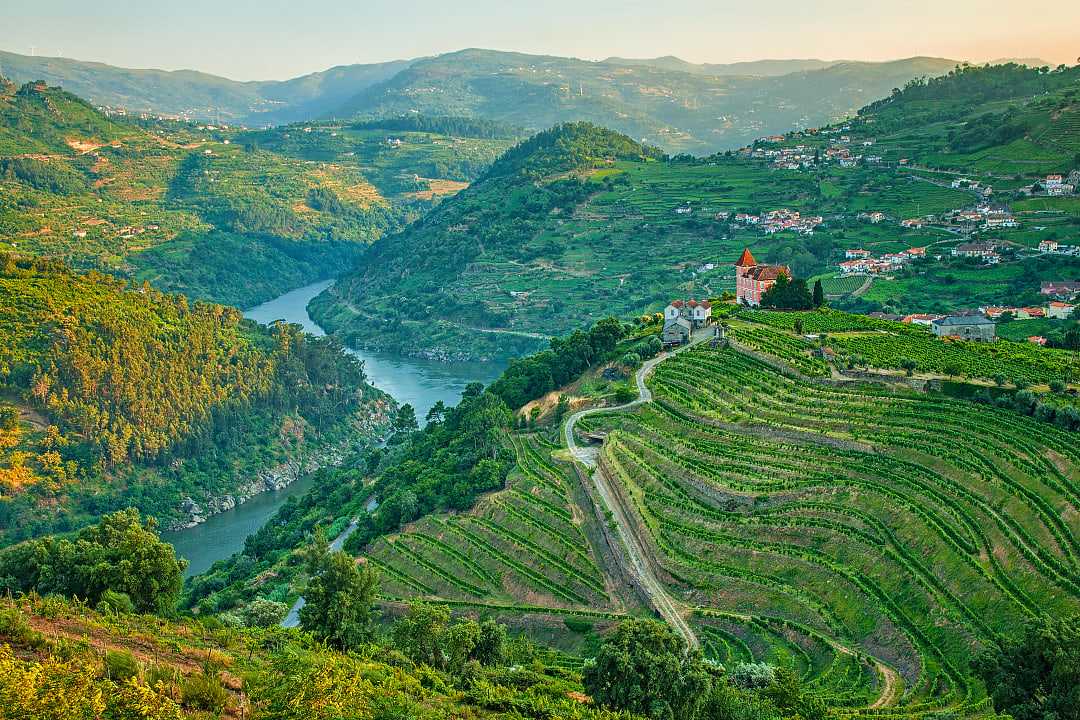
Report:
0,50,956,154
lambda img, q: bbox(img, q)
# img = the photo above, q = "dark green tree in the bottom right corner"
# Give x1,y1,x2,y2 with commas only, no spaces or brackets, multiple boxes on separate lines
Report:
973,616,1080,720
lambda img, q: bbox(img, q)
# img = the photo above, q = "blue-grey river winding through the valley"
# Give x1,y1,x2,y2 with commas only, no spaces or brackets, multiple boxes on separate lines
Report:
162,281,504,575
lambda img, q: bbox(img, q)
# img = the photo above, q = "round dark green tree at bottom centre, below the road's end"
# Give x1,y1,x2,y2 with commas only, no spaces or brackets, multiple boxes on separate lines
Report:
584,621,711,720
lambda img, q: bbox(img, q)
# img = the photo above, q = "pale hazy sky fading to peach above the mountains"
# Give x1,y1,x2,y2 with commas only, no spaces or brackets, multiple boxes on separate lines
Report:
0,0,1080,80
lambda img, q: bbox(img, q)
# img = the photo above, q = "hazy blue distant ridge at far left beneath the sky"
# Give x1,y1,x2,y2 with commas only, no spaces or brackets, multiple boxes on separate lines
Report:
0,51,409,125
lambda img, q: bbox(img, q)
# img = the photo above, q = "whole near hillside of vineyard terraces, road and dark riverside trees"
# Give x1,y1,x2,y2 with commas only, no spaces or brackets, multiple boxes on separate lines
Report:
164,307,1080,719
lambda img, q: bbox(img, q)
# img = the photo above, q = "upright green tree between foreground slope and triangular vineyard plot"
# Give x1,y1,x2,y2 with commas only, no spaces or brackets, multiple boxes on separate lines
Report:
300,536,379,649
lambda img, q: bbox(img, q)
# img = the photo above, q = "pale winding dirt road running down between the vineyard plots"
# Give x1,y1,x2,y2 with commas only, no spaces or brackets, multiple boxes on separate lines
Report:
563,331,713,648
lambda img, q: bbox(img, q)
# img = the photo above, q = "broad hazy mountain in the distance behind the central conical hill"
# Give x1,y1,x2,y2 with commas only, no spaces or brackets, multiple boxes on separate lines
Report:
334,50,956,154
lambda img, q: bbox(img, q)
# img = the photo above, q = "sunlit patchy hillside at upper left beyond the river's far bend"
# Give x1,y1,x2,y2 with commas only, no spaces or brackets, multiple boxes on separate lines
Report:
0,84,509,307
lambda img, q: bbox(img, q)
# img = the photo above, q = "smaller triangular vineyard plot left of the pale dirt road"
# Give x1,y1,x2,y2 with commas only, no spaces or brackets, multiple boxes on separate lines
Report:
366,435,611,615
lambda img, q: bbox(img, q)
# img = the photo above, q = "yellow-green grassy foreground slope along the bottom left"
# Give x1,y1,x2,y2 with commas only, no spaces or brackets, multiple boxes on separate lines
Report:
0,597,617,720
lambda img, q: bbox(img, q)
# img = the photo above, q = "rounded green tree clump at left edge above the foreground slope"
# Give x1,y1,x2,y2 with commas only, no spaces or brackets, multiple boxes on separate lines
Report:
0,510,186,613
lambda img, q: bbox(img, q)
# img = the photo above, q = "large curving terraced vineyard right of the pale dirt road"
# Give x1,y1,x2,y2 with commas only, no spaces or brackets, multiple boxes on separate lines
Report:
583,347,1080,718
